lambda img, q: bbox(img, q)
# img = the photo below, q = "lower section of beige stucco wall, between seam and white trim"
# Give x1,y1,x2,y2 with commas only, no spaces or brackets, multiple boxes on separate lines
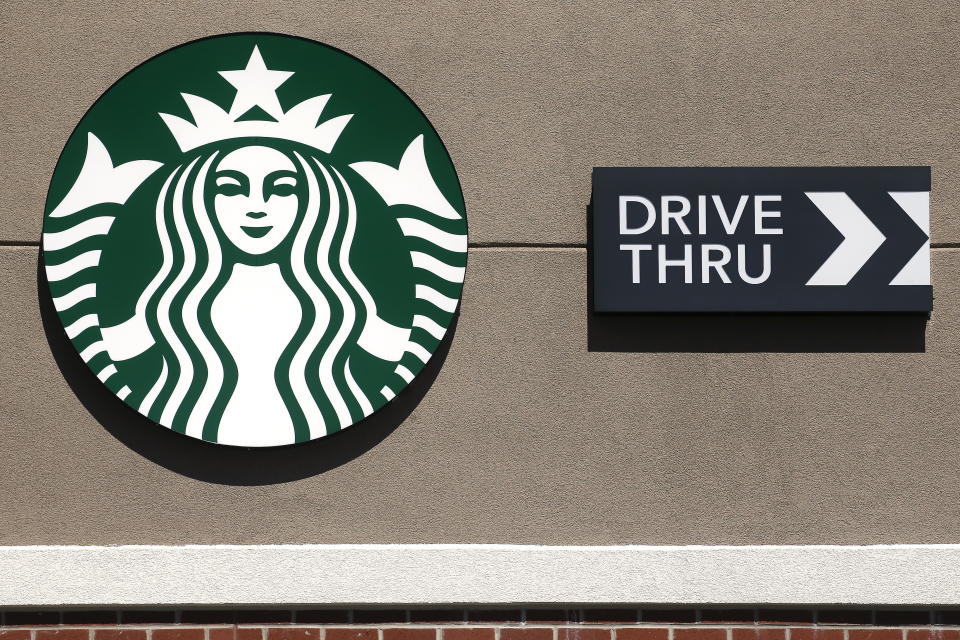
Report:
0,247,960,544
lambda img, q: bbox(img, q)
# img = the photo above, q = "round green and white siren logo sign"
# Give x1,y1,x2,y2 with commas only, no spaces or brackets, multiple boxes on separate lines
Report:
43,34,467,447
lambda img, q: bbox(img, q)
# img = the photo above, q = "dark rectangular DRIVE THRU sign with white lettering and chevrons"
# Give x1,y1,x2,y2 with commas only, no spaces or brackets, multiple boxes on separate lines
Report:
590,167,933,312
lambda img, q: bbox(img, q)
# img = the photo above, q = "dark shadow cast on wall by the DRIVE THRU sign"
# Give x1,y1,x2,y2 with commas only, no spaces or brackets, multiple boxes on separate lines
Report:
586,205,929,353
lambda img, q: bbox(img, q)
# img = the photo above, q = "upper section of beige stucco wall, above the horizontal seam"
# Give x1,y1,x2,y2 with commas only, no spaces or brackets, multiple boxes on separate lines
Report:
0,0,960,242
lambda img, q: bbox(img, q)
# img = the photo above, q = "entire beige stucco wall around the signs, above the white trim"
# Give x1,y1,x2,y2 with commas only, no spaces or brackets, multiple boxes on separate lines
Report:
0,0,960,544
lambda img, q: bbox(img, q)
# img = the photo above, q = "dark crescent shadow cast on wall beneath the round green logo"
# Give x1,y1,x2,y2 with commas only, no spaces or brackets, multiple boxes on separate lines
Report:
37,250,459,486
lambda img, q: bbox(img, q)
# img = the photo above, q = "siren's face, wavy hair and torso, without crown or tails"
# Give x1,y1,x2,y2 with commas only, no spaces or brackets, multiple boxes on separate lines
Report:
130,145,370,446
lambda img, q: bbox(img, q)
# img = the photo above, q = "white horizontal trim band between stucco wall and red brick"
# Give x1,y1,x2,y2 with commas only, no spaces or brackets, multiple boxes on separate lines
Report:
0,544,960,607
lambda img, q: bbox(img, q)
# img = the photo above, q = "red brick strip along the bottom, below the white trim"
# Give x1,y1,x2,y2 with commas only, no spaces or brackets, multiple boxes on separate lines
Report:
0,609,960,640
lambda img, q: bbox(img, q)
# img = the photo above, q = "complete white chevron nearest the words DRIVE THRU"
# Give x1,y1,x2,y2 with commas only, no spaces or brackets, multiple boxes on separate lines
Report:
806,191,886,286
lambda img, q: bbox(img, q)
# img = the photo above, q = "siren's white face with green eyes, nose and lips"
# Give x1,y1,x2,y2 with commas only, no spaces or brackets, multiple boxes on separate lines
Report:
213,146,299,255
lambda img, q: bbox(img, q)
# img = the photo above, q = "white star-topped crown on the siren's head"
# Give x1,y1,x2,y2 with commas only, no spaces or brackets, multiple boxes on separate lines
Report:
160,47,353,153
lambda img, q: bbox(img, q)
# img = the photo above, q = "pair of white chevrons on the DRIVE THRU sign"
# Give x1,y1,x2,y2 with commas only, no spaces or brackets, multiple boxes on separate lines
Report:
806,191,930,286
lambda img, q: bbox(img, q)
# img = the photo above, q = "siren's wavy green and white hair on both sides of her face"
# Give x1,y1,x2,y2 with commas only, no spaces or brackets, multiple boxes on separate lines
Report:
137,144,372,441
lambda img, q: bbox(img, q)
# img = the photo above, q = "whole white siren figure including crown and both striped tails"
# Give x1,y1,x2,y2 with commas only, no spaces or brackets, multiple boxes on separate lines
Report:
44,42,466,447
